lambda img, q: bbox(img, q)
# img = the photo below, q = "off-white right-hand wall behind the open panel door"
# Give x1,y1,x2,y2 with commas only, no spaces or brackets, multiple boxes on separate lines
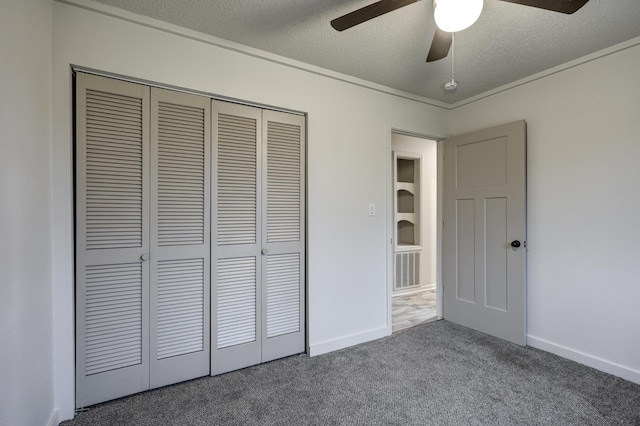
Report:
451,39,640,383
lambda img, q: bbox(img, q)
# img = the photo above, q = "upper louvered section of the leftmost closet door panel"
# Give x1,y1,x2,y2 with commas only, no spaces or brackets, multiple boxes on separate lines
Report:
83,89,143,250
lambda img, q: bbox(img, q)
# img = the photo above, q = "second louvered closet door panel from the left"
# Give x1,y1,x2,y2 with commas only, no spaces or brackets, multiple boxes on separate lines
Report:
149,88,211,388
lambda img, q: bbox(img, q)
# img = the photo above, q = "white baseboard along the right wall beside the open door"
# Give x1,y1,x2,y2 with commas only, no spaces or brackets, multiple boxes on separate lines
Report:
527,335,640,384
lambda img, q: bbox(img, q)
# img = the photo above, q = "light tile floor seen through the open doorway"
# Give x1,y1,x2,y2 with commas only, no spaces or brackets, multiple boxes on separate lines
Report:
391,289,436,333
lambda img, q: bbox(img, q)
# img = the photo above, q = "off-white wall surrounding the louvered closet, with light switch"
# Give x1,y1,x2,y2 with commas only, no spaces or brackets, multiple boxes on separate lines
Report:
53,2,449,417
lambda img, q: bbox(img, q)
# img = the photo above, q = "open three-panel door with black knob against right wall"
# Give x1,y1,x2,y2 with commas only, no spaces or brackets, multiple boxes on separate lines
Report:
442,121,526,345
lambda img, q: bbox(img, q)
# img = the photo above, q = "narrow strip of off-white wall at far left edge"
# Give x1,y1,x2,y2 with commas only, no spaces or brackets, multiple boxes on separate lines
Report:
0,0,57,425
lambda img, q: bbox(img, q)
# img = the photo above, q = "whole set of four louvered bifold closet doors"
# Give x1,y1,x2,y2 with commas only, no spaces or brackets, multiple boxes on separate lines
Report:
75,72,305,407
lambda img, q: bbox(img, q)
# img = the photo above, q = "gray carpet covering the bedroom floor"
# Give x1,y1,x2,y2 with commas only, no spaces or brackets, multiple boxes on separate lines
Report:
62,321,640,426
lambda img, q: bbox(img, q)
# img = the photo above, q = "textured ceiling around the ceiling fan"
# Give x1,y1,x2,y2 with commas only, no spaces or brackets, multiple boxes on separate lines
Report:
92,0,640,103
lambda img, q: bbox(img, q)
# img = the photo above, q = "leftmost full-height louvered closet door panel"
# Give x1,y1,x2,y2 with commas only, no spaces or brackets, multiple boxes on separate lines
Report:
76,73,149,407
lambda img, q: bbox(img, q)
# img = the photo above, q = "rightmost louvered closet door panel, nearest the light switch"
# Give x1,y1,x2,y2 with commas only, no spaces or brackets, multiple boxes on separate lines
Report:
261,110,305,362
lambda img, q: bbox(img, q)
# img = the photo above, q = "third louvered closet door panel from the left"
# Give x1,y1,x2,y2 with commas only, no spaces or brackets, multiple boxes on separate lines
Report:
211,101,262,374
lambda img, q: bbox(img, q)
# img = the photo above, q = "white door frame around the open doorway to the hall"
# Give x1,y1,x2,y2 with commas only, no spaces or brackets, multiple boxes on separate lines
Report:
386,124,446,335
